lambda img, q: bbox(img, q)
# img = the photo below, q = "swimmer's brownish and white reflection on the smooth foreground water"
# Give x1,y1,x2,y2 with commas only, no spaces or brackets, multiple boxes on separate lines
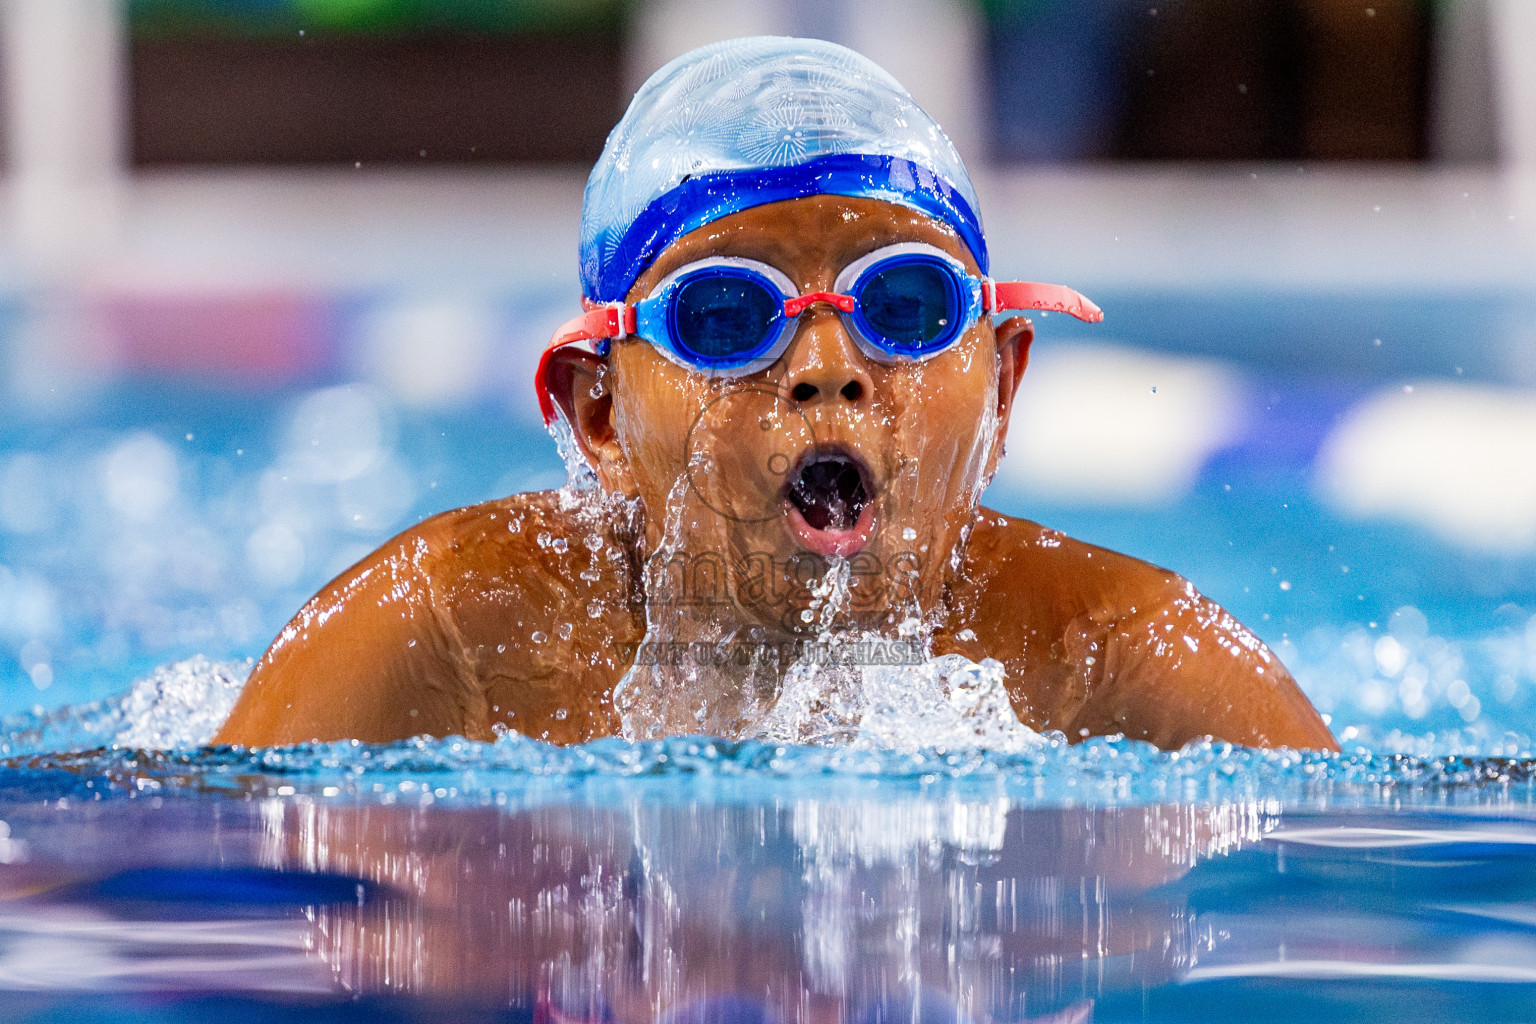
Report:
285,800,1266,1021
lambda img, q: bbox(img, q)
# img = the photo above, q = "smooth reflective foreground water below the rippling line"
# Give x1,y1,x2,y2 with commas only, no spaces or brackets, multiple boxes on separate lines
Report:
0,777,1536,1024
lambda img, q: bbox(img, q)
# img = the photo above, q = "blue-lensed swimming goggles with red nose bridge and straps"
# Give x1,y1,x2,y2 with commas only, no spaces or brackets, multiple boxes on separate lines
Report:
536,243,1104,424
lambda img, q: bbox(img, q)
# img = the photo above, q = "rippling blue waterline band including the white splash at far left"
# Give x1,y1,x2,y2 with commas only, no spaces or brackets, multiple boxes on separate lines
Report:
0,659,1536,809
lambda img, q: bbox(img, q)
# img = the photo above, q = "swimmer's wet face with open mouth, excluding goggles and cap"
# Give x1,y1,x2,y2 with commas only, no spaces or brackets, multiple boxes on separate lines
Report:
562,197,1032,629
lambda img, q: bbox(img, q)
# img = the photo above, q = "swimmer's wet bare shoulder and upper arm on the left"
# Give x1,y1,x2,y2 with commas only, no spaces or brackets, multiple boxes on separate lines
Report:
217,491,633,745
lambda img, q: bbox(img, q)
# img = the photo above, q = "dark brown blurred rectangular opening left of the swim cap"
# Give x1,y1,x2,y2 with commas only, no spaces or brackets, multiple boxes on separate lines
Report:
129,0,628,166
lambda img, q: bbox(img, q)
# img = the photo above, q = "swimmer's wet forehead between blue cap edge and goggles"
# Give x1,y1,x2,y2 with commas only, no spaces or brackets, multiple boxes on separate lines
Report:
630,195,980,299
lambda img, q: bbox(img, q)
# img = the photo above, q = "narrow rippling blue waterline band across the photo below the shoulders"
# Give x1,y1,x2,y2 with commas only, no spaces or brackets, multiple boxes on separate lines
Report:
9,734,1536,811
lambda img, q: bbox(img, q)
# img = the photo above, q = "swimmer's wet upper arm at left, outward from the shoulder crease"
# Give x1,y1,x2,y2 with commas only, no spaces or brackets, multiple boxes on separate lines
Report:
214,534,465,746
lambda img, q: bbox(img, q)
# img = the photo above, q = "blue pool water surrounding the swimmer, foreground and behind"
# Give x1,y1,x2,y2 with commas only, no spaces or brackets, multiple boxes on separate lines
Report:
0,288,1536,1024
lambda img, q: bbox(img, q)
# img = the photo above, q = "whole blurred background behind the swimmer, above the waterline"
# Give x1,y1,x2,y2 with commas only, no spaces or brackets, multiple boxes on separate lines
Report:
0,0,1536,748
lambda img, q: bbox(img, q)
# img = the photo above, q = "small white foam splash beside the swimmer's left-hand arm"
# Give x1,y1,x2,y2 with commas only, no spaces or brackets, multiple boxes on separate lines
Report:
112,656,252,751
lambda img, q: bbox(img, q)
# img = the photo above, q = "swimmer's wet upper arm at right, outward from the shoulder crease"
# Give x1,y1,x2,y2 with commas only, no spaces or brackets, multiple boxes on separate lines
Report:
1077,580,1338,751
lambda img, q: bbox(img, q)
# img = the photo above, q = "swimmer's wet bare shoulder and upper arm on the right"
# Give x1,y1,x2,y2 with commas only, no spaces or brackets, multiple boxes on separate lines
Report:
962,510,1335,748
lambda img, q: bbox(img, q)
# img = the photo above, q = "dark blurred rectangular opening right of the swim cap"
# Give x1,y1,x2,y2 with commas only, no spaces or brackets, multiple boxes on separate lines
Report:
985,0,1435,161
